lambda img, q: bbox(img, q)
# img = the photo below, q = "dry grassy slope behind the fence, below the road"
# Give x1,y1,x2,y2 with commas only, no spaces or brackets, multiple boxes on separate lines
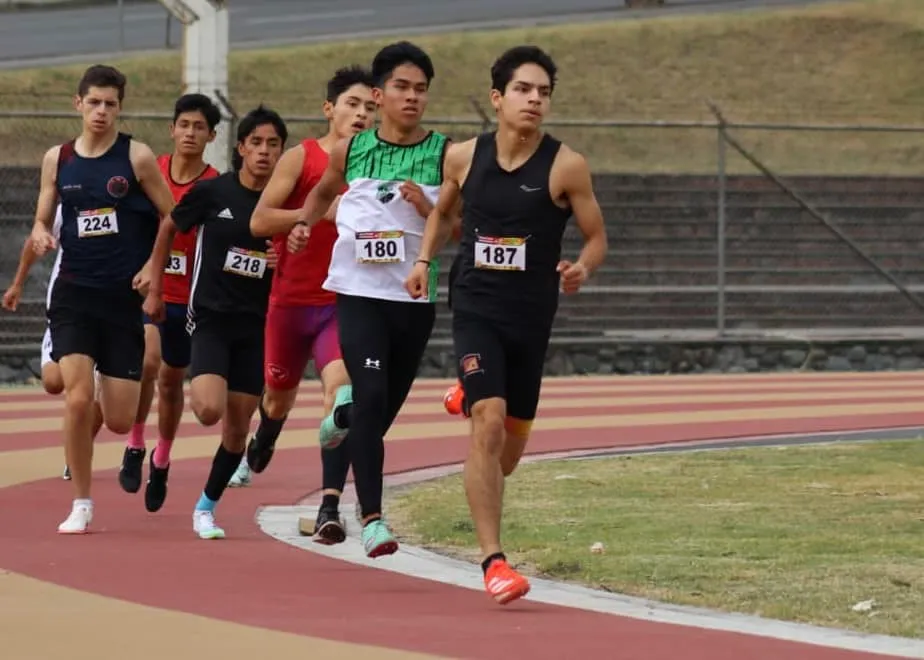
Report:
0,0,924,174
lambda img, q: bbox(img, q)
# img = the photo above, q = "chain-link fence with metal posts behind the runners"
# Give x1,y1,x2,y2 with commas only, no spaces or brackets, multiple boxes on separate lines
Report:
0,111,924,356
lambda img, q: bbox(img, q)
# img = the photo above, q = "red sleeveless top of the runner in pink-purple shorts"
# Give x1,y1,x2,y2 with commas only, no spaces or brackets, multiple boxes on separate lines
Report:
270,139,337,307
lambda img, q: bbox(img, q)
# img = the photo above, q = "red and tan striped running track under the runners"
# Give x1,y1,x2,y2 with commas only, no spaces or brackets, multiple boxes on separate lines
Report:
0,372,924,660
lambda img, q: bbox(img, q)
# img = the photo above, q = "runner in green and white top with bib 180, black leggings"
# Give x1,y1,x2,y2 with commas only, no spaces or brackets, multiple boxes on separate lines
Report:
289,42,449,557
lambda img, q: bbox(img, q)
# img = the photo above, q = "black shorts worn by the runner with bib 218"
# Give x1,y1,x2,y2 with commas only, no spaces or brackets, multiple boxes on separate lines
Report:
188,310,265,396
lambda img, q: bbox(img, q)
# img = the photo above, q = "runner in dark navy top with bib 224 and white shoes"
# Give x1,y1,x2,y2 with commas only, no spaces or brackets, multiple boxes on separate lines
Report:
31,65,173,534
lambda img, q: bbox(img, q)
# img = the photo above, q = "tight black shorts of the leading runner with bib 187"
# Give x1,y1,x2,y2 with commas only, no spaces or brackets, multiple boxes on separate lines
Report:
452,310,551,421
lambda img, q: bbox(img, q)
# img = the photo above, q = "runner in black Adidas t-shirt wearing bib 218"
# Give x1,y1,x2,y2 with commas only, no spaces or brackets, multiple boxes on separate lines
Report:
144,106,288,539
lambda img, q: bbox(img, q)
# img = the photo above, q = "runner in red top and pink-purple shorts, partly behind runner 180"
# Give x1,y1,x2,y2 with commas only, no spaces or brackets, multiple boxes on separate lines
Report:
231,67,375,543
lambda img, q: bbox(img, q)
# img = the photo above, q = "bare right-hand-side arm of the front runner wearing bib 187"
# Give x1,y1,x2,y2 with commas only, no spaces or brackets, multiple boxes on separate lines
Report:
561,147,607,274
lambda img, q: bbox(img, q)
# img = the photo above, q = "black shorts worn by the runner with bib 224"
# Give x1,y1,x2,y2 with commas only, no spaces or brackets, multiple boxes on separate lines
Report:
48,277,144,381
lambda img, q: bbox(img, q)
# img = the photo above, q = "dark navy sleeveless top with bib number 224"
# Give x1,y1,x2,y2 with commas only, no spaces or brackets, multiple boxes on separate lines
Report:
57,133,160,291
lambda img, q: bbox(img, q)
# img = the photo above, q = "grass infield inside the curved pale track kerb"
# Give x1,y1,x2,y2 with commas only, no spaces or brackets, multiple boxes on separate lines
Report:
388,440,924,637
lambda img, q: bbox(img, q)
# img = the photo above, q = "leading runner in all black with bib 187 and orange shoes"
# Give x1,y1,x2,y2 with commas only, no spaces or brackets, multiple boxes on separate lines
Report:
407,46,607,604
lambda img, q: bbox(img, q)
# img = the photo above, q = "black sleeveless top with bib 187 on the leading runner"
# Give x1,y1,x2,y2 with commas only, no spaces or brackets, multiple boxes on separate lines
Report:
449,132,571,329
